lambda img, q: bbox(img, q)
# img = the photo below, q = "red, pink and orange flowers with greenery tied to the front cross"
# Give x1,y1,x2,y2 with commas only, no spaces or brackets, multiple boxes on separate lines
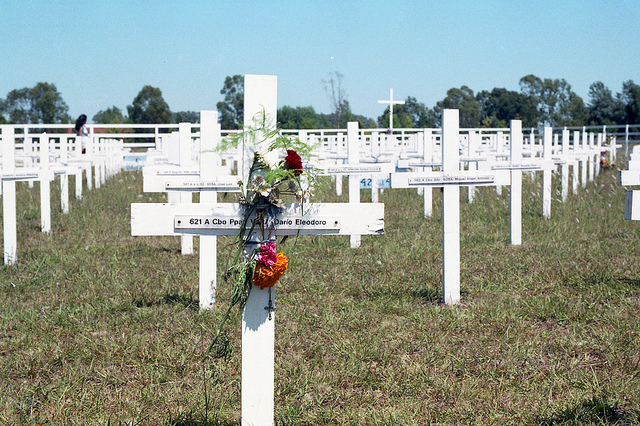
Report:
207,112,317,359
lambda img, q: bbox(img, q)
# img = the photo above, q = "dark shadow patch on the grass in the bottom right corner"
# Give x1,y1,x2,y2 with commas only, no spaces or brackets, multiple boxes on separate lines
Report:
536,398,640,426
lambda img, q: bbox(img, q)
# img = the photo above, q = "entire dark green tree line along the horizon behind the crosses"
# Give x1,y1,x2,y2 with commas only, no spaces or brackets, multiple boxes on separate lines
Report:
0,72,640,130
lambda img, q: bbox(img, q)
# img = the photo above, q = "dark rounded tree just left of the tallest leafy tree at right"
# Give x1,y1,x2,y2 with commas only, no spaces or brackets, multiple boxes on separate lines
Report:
476,87,538,127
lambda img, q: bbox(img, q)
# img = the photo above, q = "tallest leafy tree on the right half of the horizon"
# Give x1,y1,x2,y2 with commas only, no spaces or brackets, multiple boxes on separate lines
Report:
520,74,586,126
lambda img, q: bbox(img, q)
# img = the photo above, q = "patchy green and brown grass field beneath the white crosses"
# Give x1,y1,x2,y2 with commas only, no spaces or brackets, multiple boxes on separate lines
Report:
0,161,640,425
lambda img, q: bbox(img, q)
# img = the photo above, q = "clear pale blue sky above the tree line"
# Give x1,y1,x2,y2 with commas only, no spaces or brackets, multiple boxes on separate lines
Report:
0,0,640,119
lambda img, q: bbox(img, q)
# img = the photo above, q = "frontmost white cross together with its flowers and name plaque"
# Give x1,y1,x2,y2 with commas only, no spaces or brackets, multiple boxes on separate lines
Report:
131,75,384,425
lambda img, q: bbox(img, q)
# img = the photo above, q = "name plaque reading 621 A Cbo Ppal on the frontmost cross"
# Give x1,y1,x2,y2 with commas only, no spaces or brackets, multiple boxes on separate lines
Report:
173,214,340,231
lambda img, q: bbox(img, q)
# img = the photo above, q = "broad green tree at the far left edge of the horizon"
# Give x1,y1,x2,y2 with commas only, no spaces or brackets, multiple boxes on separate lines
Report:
2,83,71,124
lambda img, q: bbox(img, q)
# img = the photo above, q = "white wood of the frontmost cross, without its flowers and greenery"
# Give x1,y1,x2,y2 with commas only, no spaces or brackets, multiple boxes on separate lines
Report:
131,75,384,425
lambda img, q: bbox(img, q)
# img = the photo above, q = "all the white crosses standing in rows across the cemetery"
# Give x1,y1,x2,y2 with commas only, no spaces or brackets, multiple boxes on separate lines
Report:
0,75,640,425
